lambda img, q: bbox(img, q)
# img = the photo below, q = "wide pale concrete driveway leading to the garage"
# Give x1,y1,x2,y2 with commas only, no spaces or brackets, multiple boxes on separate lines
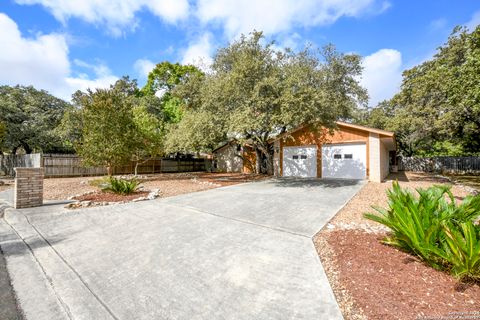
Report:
0,180,363,319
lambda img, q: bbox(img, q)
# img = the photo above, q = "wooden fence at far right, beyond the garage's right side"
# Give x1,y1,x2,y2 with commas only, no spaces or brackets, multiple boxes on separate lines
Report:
398,156,480,173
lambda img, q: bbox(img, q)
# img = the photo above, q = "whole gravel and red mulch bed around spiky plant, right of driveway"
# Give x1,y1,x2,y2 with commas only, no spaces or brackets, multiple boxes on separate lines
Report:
314,173,480,319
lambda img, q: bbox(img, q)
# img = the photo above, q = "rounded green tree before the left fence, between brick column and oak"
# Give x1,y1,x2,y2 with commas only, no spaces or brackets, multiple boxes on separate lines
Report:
73,77,164,174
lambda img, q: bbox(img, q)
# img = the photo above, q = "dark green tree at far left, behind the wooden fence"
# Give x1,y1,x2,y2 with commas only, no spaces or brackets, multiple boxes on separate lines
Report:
0,86,70,153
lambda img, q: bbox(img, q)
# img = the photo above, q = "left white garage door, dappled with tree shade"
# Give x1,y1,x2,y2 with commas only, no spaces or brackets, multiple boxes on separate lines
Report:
283,146,317,178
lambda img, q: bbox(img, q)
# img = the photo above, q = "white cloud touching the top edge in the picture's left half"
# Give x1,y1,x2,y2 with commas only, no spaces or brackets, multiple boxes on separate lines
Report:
15,0,189,36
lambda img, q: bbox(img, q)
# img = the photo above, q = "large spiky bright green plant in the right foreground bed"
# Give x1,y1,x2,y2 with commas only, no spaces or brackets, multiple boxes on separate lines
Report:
364,182,480,279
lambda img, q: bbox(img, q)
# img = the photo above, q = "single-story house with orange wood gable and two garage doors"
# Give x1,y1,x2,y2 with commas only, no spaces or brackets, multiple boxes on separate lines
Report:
213,122,396,182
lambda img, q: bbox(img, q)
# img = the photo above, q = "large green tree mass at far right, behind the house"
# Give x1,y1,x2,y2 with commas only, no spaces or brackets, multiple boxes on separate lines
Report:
365,26,480,155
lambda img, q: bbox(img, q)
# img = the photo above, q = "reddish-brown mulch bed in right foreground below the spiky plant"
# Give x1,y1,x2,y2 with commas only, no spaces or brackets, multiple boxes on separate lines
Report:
316,230,480,320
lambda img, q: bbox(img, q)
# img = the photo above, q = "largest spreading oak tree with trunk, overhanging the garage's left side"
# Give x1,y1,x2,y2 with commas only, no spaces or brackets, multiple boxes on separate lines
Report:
169,32,367,171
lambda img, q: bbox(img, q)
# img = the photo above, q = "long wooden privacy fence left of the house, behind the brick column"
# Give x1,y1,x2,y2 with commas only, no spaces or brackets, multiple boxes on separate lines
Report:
2,154,211,177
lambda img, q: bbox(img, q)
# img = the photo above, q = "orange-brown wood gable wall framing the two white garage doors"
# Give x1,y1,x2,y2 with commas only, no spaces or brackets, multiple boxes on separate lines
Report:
278,125,370,178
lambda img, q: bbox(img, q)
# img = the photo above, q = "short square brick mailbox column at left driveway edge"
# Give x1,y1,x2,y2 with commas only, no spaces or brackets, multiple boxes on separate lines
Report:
13,168,44,209
